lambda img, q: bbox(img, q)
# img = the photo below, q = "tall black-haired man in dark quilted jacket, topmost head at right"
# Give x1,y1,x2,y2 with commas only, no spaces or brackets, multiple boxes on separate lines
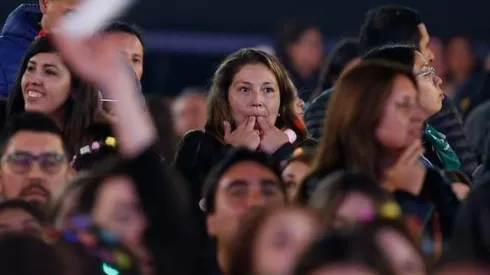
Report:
305,5,479,179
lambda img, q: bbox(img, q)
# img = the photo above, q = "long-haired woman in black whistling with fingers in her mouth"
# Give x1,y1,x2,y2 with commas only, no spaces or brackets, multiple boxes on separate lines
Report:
174,49,307,209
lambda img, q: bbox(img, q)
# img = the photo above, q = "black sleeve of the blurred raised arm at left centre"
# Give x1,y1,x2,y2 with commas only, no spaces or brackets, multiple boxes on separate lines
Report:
127,145,202,275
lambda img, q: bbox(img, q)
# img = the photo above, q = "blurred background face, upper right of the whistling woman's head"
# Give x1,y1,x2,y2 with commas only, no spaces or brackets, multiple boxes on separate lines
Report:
289,28,323,71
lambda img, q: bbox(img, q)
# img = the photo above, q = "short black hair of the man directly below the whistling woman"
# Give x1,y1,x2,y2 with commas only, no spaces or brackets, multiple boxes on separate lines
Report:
201,148,287,214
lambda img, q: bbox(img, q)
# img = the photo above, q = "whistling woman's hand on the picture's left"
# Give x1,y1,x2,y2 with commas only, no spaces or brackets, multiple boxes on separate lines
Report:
223,116,260,151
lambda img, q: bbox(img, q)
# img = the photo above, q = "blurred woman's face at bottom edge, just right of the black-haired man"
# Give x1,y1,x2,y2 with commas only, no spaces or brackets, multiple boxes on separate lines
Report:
252,210,319,275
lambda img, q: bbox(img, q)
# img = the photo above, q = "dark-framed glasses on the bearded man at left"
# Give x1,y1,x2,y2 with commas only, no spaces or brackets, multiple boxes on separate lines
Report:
3,151,67,174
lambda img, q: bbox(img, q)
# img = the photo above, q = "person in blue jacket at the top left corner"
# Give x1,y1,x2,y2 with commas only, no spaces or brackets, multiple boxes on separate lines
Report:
0,0,80,98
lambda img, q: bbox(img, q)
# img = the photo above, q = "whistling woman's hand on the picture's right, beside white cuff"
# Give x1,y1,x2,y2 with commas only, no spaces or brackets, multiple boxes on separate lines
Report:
257,117,289,154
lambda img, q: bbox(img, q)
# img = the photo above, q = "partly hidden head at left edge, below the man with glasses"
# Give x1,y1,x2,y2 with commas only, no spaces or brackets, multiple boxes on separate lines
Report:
0,199,47,236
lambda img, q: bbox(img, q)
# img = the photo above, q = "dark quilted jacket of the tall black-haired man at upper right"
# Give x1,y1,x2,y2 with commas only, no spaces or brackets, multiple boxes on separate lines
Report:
305,88,479,178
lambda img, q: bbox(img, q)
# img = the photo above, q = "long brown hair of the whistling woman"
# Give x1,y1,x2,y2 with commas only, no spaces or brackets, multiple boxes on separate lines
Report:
205,48,307,144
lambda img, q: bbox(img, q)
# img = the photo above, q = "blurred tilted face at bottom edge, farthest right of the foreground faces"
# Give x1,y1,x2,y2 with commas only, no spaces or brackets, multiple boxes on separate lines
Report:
377,229,426,275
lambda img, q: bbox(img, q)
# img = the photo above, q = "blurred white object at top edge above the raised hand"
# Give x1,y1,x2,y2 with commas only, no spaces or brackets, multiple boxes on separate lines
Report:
57,0,135,38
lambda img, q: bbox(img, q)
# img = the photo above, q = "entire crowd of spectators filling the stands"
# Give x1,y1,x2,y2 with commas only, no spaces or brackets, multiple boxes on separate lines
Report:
0,0,490,275
